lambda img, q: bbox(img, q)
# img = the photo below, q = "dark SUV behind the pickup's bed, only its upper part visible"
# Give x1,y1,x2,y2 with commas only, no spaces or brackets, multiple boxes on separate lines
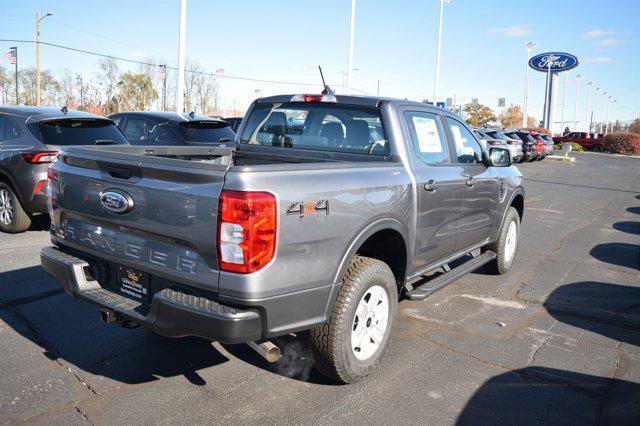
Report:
109,111,236,146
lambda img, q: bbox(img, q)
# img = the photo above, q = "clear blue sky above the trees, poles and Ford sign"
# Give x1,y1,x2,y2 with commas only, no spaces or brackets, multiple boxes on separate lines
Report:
0,0,640,125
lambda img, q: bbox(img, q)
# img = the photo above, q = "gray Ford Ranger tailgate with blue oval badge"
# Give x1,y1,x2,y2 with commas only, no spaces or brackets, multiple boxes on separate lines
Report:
50,147,228,292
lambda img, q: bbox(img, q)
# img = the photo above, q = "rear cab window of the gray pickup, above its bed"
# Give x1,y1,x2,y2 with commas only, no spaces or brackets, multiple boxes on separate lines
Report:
240,102,390,155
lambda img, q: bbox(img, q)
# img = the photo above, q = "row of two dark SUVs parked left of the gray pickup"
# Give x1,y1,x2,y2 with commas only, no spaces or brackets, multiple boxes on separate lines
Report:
0,106,242,233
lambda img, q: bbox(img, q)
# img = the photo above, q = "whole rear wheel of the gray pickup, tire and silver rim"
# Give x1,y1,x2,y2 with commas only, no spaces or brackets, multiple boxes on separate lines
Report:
309,256,398,383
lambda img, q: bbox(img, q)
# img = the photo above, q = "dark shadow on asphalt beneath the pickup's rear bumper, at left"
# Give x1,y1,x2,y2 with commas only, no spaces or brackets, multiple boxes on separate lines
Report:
0,267,228,385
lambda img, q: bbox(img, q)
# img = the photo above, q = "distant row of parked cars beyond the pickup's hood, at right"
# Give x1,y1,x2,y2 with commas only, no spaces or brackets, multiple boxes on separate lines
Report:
473,128,554,163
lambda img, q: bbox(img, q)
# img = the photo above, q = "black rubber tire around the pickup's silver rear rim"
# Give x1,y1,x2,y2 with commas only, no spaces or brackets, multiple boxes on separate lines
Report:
309,256,398,383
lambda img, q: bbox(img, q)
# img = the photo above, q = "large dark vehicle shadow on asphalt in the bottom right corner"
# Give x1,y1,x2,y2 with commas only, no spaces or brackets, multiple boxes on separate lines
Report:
456,367,640,425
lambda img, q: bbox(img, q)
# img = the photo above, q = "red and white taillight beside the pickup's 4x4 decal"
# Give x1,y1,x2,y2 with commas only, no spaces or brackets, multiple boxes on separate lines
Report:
218,190,276,274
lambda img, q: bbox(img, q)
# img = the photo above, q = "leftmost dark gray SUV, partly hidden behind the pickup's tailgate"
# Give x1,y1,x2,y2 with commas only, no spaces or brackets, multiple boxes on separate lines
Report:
0,107,127,233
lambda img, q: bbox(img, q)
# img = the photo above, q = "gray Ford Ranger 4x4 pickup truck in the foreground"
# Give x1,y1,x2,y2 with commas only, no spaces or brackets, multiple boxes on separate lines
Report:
41,94,524,383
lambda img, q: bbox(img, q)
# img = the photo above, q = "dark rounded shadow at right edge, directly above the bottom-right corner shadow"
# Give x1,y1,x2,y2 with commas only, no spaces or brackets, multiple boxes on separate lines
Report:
543,281,640,346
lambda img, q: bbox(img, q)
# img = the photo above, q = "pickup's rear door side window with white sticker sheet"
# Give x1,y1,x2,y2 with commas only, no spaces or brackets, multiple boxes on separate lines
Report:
404,111,449,164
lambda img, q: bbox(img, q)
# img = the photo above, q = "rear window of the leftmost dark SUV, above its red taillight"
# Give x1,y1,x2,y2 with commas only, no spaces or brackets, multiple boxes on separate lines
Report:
38,119,128,146
